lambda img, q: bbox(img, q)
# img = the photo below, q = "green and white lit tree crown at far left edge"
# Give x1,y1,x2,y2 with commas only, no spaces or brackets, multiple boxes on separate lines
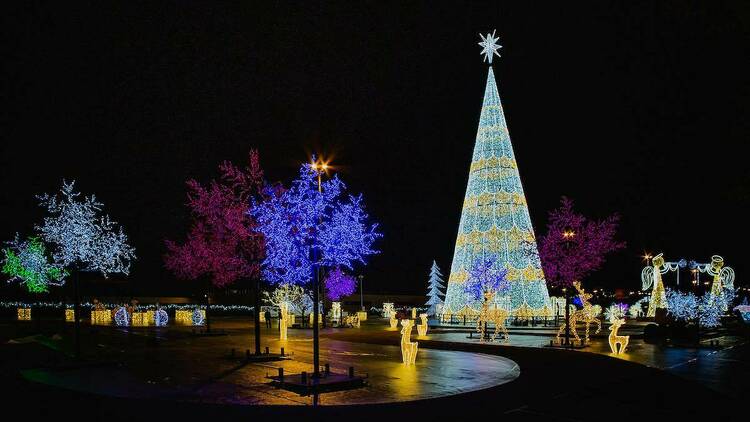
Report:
2,234,68,293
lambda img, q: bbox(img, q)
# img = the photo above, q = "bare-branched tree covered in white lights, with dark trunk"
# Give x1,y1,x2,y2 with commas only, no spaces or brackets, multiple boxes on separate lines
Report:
37,181,135,357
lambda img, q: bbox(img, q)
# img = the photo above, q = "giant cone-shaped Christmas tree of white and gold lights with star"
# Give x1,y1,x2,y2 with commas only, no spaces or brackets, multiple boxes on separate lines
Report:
444,32,550,317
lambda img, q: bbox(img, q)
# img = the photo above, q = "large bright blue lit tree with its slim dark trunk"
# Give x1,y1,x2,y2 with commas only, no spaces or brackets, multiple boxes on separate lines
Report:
249,164,382,375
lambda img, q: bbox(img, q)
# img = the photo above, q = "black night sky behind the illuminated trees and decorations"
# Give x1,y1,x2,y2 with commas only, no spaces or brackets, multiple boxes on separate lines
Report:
0,1,750,295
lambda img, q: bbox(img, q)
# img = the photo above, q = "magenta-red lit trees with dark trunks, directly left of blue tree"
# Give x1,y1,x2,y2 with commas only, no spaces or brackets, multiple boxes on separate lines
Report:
164,150,264,354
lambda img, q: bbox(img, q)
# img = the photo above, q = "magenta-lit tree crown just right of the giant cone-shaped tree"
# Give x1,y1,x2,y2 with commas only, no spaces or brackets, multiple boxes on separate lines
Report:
539,197,625,287
